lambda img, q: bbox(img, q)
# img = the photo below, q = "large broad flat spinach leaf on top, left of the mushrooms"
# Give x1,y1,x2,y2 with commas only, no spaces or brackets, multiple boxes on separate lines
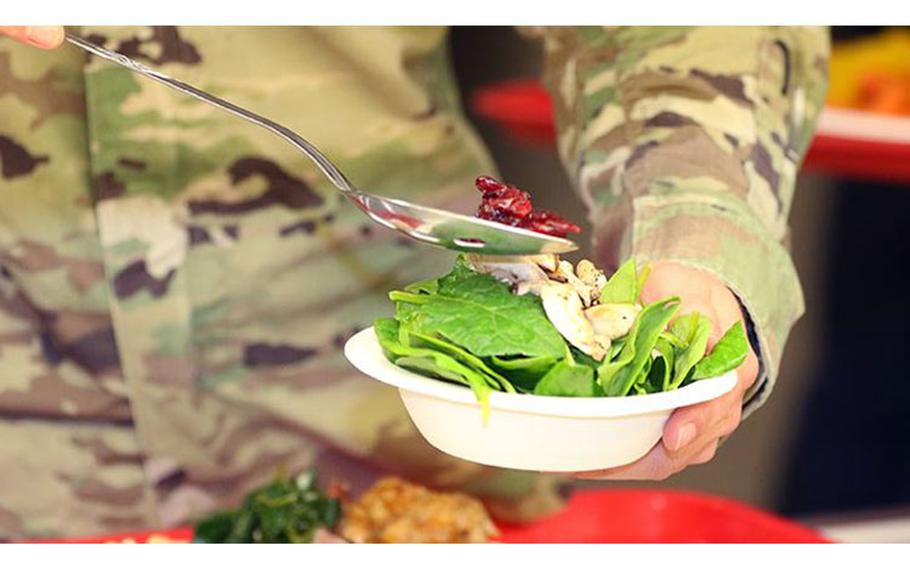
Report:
407,263,566,358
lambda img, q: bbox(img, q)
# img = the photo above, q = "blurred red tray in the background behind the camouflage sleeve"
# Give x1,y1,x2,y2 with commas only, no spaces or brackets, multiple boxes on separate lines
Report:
471,80,910,183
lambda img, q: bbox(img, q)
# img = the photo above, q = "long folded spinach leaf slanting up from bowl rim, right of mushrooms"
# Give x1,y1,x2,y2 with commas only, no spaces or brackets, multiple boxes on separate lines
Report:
598,297,679,396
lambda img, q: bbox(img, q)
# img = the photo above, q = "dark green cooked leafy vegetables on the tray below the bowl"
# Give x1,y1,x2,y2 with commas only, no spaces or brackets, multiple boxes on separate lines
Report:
194,471,341,543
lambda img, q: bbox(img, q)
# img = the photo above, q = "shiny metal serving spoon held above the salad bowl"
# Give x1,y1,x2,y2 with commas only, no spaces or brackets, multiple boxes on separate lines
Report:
66,33,578,255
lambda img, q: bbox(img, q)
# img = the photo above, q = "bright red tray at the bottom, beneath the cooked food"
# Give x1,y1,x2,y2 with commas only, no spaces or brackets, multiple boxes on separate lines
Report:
26,489,831,543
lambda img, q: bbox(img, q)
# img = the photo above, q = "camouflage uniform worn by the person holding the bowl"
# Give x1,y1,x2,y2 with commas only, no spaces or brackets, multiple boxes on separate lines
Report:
0,28,827,539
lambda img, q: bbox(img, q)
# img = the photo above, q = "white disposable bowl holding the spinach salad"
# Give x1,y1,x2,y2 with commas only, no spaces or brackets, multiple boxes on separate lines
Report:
344,328,736,472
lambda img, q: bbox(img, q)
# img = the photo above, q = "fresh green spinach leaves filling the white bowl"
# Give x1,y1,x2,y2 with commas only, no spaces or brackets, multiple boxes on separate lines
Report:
375,256,748,416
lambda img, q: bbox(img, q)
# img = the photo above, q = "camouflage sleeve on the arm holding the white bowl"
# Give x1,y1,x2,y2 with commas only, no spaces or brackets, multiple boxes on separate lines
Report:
531,27,830,413
